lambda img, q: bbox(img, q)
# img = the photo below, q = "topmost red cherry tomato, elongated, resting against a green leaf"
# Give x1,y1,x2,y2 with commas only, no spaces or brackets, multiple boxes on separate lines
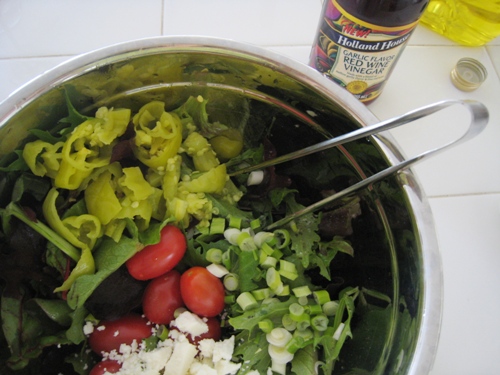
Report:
126,225,186,280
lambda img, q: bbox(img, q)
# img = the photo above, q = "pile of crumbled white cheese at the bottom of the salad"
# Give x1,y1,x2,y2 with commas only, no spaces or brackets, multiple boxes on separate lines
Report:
92,312,241,375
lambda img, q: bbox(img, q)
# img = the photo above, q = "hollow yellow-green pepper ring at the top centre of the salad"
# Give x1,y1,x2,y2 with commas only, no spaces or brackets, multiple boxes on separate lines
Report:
132,101,182,168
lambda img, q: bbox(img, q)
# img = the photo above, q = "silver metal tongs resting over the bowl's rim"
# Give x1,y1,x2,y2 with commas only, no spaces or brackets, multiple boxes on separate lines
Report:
230,100,489,230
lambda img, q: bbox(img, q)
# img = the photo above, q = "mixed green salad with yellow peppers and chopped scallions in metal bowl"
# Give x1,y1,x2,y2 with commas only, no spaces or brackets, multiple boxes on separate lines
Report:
0,97,368,375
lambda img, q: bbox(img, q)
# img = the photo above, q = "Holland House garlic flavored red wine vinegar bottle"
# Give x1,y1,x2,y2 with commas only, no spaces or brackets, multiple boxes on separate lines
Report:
309,0,428,104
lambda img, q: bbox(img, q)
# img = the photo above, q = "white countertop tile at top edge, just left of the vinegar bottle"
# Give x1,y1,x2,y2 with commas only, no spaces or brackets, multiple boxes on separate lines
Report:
163,0,321,46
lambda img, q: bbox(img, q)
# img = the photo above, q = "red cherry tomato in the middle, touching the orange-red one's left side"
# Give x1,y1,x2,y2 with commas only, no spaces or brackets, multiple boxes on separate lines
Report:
142,270,184,324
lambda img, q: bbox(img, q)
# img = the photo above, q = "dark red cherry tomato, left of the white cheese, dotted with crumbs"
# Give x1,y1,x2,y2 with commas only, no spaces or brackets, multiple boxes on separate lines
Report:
89,314,151,354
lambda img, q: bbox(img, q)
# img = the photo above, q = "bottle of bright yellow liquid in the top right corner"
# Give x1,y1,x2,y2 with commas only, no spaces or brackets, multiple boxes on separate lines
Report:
420,0,500,46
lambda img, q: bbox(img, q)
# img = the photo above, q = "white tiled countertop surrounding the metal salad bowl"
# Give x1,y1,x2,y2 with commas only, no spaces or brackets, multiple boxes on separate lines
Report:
0,0,500,375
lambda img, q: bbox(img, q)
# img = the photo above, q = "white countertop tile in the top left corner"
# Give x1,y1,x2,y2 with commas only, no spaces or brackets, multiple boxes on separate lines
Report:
0,0,162,58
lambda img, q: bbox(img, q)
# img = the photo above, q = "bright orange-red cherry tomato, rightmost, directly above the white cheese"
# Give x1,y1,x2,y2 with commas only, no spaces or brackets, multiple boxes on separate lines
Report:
181,267,225,317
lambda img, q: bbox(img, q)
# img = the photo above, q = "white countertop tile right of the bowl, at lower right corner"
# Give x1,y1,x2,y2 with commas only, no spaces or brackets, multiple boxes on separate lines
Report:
430,194,500,375
